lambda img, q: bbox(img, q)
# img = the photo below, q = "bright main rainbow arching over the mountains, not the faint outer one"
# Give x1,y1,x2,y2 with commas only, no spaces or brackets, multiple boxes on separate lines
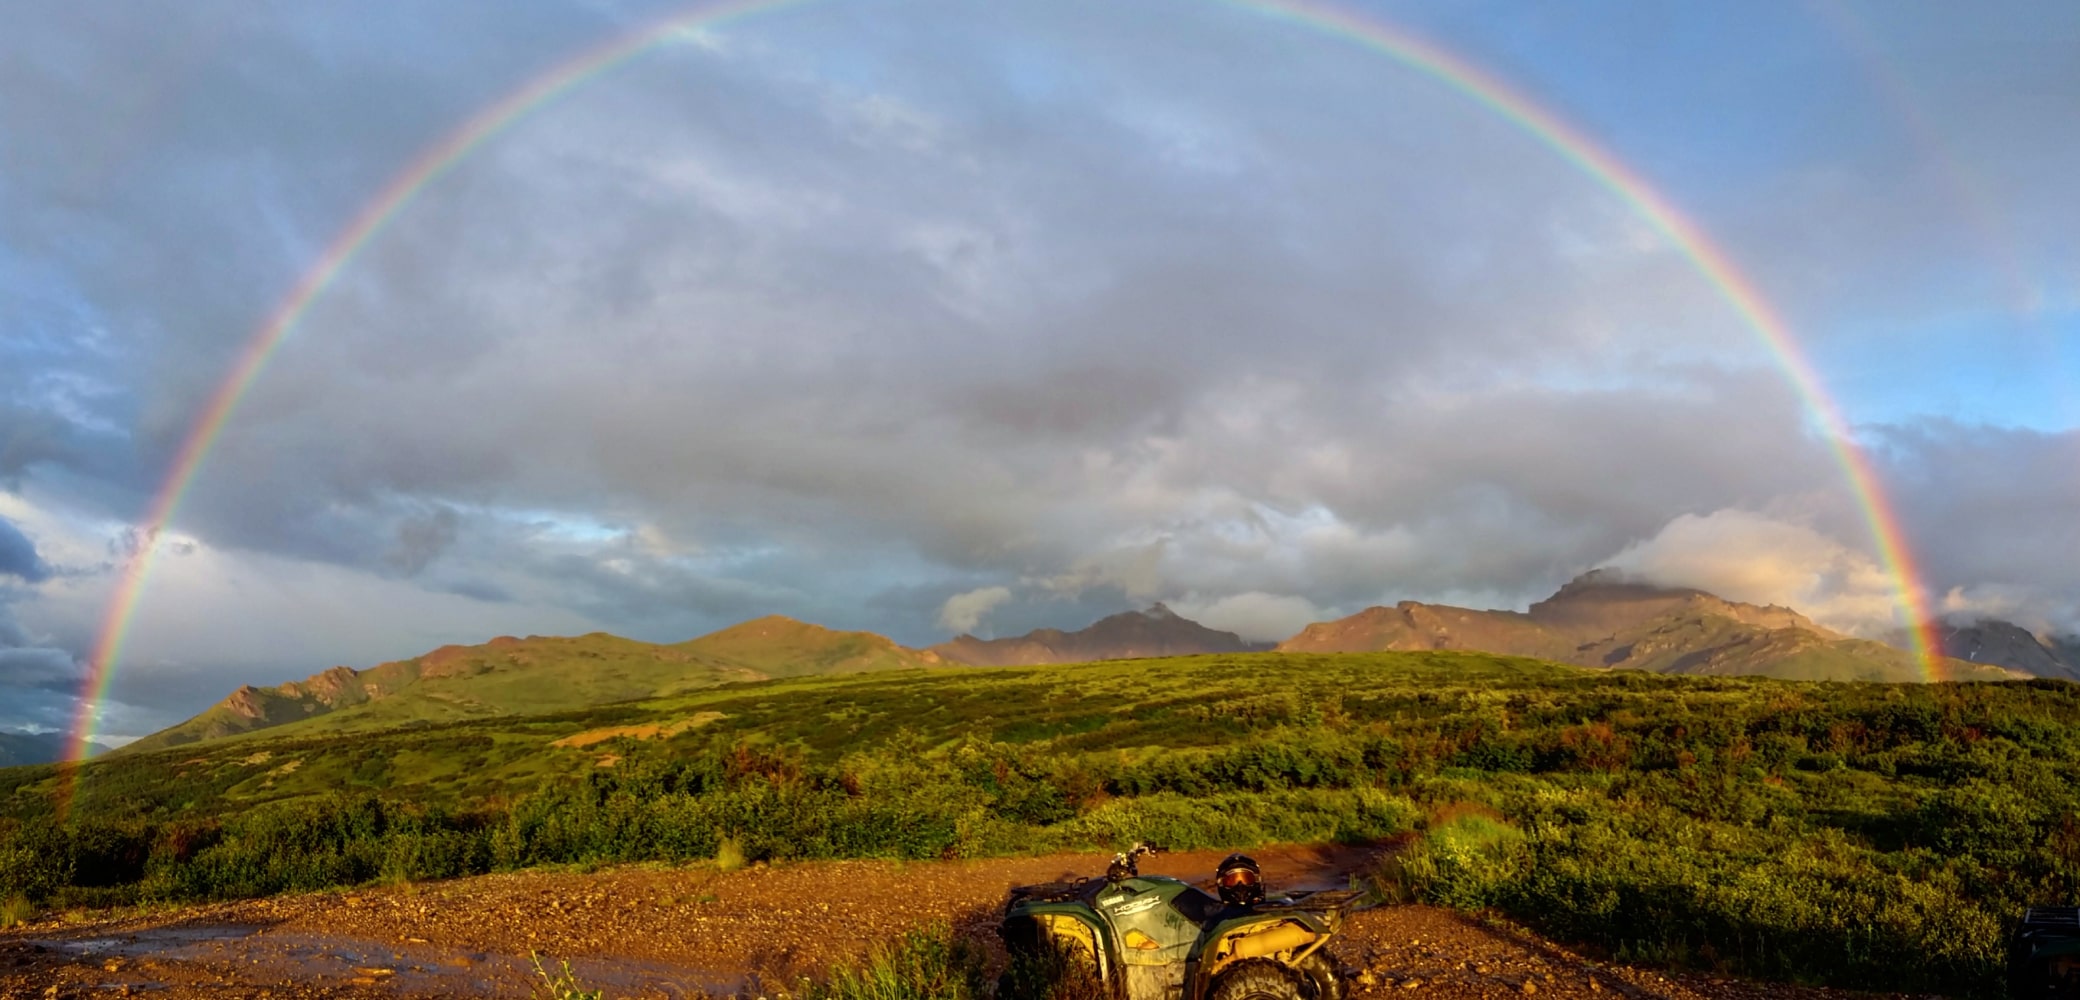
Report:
60,0,1939,794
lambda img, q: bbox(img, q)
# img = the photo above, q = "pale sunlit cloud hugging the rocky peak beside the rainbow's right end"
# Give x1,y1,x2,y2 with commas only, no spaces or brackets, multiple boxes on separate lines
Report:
1606,509,1899,636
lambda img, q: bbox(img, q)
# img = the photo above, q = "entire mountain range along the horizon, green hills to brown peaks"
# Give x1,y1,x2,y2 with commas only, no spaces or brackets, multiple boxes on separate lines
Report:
101,570,2080,763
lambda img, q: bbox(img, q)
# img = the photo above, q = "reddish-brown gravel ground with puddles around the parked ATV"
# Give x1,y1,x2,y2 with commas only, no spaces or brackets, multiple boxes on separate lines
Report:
0,846,1946,1000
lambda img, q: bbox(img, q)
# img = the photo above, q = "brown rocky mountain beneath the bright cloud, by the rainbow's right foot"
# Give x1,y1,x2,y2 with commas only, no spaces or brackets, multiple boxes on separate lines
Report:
1277,570,2024,682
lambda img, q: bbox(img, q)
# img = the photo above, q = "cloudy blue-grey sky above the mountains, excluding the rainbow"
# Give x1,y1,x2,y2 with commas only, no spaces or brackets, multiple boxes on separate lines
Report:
0,0,2080,740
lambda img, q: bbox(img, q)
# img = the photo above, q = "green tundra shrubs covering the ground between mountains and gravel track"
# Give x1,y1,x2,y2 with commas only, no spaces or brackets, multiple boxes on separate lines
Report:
0,653,2080,994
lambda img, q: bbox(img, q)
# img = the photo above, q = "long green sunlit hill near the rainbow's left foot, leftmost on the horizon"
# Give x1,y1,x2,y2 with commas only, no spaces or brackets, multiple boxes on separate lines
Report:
125,617,938,753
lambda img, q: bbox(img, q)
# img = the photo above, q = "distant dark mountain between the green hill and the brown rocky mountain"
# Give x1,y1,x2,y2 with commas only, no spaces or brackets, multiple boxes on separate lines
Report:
932,603,1269,667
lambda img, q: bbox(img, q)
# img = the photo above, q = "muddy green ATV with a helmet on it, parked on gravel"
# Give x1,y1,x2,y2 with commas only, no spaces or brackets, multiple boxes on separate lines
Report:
996,844,1358,1000
